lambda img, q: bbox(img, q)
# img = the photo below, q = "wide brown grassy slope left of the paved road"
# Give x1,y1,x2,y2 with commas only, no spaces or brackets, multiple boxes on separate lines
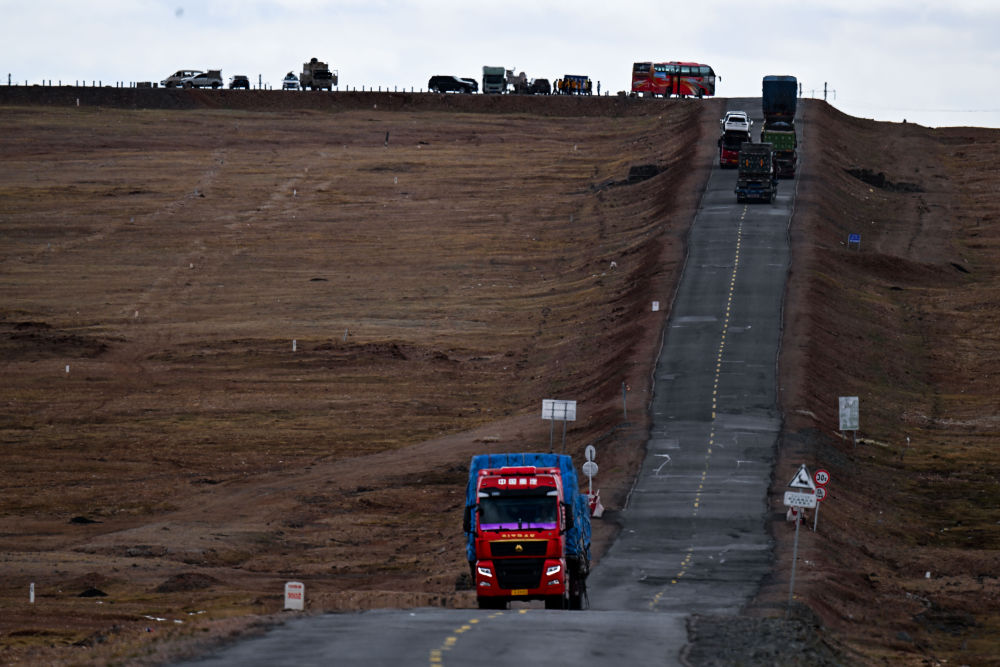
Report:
0,91,718,663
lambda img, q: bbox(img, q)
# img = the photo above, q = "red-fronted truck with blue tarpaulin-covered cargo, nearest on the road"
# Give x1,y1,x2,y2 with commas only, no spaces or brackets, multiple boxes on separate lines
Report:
463,453,590,609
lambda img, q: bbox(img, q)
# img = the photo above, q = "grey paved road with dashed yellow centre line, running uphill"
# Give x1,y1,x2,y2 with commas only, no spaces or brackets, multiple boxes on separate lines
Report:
180,99,794,667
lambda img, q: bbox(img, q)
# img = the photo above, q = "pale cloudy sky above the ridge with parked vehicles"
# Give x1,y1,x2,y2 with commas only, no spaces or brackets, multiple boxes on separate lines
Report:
0,0,1000,127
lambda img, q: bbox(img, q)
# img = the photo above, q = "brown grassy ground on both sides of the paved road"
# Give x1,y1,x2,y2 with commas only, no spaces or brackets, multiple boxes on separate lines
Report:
0,91,1000,664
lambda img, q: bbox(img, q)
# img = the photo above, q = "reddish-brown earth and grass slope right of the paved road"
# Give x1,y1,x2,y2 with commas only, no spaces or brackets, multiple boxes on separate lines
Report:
760,103,1000,664
